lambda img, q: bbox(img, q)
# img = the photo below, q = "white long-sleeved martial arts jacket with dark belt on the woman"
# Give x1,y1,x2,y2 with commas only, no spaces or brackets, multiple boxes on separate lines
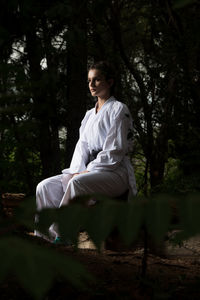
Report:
62,96,137,196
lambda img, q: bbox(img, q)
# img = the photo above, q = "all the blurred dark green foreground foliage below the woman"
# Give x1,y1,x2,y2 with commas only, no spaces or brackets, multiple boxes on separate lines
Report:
0,193,200,299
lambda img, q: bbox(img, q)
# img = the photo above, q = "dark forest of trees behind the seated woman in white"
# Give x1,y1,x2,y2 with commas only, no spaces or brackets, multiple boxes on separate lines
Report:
0,0,200,195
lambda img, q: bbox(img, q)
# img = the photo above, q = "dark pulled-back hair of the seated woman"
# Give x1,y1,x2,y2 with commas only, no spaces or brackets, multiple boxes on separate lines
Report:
88,60,116,95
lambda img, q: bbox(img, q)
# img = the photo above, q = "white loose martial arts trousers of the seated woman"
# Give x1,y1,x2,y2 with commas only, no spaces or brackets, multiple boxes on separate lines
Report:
35,171,128,238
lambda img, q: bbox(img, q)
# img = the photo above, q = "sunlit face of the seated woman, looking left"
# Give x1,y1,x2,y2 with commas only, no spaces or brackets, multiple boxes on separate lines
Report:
88,69,113,99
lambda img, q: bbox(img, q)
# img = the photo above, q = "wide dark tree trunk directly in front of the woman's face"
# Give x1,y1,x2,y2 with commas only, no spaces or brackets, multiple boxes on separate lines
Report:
65,0,87,166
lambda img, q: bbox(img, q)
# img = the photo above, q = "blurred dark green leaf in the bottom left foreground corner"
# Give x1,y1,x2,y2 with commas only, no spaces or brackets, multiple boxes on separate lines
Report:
0,237,92,299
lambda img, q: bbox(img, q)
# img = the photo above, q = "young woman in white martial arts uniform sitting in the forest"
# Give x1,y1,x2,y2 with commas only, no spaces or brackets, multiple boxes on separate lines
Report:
36,62,136,238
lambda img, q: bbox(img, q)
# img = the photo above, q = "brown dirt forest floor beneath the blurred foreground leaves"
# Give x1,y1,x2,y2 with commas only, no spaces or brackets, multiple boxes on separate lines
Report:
0,235,200,300
